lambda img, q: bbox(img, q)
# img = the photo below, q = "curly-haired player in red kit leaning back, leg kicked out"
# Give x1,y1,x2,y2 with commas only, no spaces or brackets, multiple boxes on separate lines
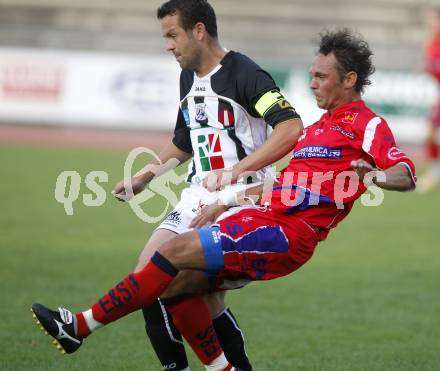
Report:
32,30,415,370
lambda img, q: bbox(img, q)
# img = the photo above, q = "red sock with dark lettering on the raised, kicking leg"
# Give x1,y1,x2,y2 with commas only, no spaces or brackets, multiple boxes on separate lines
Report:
76,252,178,337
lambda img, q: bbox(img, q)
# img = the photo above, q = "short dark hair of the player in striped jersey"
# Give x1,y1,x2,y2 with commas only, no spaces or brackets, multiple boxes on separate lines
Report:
157,0,217,38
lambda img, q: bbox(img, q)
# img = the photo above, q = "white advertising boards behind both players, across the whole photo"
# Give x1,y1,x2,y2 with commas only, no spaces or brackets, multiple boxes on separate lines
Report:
0,48,437,143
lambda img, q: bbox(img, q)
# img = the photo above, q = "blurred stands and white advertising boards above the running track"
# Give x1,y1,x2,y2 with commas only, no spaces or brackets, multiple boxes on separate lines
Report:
0,0,438,143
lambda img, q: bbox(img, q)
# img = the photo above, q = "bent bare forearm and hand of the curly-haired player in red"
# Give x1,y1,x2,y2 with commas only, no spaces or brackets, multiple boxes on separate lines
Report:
351,160,416,192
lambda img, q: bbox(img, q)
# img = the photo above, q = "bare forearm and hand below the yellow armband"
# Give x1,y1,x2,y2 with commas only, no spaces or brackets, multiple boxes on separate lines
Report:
203,119,303,192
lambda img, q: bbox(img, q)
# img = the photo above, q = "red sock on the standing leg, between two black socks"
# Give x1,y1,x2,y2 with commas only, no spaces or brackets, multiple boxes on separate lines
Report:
163,295,226,365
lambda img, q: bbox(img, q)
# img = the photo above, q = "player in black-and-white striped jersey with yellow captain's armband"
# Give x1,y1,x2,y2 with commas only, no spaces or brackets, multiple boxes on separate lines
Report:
83,0,302,371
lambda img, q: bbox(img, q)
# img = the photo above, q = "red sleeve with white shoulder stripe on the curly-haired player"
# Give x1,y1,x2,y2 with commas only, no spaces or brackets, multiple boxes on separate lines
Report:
359,116,416,184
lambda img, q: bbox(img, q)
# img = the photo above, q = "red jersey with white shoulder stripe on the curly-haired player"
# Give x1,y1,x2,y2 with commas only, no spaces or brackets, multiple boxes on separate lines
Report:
270,100,415,239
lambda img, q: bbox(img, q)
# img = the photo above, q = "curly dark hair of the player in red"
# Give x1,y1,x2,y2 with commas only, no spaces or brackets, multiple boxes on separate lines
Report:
318,28,375,93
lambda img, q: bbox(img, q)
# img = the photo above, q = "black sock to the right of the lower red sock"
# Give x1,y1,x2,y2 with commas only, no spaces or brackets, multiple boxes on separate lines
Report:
212,308,252,371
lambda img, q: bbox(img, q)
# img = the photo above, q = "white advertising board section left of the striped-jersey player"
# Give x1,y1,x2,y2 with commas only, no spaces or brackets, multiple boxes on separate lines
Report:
0,49,180,130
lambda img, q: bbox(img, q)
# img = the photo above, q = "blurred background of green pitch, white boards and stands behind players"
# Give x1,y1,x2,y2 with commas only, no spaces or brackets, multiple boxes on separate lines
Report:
0,0,440,371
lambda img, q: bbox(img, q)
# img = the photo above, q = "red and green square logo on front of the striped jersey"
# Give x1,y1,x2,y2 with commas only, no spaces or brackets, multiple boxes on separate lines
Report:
197,134,225,171
